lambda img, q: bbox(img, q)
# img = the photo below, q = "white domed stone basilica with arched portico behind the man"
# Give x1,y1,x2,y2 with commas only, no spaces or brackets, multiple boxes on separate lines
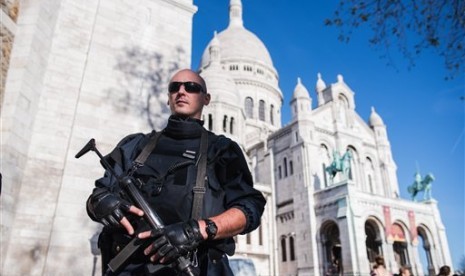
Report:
194,0,450,275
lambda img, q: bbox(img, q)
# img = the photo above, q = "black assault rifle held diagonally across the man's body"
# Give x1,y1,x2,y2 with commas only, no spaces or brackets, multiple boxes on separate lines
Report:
75,138,199,276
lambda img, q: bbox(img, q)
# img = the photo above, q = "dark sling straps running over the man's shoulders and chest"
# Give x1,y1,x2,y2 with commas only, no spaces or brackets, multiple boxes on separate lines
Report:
134,129,208,219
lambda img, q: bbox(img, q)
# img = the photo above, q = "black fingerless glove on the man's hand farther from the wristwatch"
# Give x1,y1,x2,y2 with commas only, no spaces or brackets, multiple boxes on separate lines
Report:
87,190,131,226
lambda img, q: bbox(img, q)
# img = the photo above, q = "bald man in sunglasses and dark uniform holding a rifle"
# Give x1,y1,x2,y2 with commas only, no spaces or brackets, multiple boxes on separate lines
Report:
87,69,266,275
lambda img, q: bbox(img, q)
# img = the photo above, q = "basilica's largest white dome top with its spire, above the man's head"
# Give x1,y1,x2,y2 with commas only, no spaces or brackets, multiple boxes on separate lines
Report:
200,1,274,68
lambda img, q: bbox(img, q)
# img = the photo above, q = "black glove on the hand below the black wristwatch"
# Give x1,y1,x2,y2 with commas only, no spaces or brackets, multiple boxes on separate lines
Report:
149,219,203,264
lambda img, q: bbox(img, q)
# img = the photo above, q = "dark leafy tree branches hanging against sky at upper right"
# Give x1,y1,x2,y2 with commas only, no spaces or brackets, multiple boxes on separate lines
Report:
325,0,465,79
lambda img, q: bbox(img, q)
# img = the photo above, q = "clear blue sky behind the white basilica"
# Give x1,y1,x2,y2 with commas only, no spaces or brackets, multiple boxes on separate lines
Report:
192,0,465,267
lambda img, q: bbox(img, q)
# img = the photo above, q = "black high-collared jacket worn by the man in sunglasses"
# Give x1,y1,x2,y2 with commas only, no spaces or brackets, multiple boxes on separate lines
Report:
91,116,266,272
